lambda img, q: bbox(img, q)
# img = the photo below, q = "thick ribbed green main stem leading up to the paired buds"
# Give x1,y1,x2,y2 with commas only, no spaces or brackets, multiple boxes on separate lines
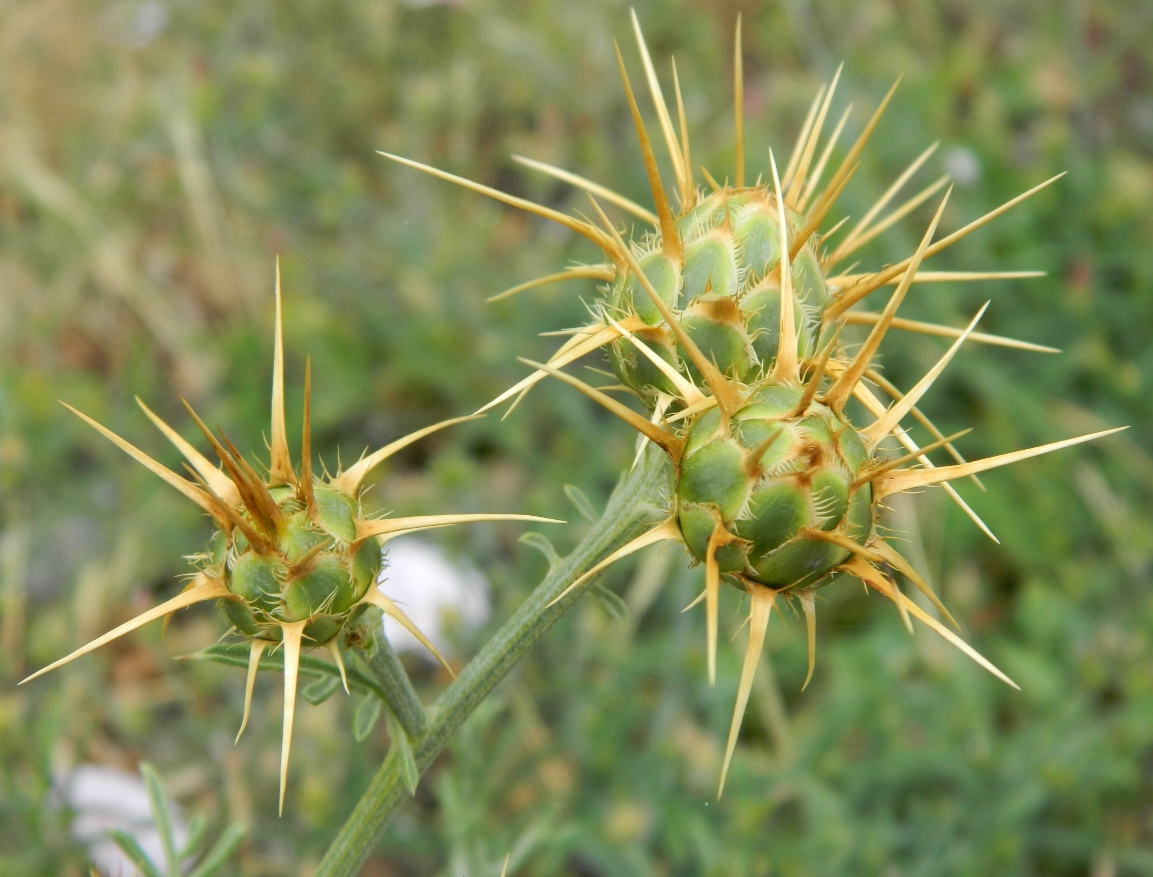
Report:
312,448,670,877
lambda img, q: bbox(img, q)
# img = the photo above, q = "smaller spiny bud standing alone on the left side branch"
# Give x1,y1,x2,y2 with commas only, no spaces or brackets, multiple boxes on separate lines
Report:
21,265,559,812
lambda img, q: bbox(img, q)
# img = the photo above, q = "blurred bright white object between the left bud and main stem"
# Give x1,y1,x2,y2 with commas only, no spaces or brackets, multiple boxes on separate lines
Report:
377,536,491,656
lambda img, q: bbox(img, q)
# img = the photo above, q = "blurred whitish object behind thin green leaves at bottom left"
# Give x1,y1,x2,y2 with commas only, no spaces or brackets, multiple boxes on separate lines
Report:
58,764,188,877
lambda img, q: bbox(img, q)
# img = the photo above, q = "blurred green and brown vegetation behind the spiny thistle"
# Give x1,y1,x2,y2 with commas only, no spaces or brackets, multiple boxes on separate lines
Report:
0,0,1153,877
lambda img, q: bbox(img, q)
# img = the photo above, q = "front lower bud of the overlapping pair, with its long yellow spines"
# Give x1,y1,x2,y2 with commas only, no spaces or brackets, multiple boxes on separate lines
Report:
527,193,1116,794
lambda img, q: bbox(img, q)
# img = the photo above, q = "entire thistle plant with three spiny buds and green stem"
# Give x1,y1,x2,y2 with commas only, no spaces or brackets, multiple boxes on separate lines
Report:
25,16,1129,877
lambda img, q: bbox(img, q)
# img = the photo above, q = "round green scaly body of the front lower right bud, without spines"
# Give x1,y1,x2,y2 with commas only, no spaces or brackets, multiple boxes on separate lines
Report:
677,383,874,590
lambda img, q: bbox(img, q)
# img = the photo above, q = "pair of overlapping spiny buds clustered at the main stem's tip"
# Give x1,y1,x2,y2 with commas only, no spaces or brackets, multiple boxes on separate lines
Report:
383,13,1117,794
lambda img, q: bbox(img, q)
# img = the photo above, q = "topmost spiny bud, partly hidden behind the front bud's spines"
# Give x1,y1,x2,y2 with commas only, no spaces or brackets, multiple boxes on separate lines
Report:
382,15,1057,424
